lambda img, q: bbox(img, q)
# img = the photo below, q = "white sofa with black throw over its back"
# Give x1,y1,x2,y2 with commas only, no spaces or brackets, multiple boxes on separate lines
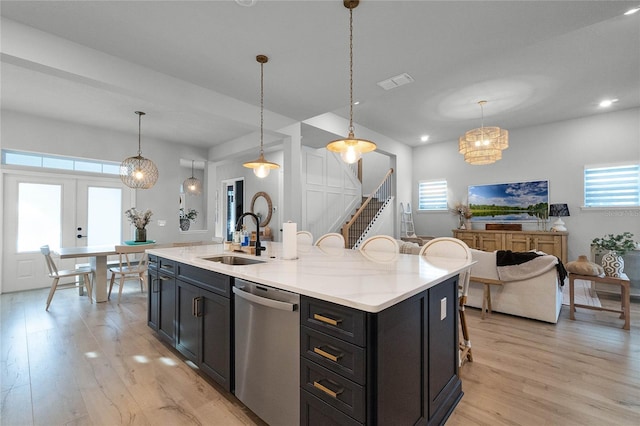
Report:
467,249,568,324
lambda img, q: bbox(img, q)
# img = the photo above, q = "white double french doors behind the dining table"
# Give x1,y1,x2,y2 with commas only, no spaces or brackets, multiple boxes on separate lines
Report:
0,173,135,292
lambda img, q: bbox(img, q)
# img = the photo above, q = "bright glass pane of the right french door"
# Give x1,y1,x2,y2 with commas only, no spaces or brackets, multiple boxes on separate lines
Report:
87,186,124,246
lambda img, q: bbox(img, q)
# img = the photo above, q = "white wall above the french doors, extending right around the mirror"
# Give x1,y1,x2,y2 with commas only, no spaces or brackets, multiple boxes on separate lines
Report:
0,109,213,243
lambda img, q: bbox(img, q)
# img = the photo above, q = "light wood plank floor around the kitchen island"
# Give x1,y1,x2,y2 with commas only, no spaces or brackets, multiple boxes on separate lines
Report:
0,283,640,426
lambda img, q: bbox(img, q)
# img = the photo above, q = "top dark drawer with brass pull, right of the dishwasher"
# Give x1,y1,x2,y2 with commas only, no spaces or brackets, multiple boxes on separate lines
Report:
300,297,366,346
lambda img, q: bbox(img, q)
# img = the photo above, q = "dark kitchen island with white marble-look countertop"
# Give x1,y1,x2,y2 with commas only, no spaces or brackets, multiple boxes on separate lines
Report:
148,243,470,425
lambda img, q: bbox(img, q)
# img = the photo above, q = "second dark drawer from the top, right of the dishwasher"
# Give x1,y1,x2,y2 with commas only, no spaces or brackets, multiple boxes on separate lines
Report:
300,326,366,385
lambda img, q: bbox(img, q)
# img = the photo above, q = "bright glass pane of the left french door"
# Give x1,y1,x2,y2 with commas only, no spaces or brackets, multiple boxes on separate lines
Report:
18,182,62,253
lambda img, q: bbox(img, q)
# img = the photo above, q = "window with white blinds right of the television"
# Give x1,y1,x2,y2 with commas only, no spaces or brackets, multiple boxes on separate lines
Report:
584,164,640,207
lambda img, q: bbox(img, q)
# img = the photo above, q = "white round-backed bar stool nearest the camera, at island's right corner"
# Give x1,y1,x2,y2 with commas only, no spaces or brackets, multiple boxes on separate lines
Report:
420,237,473,365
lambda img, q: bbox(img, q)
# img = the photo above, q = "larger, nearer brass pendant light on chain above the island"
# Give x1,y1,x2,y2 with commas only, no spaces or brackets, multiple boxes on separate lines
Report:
327,0,376,164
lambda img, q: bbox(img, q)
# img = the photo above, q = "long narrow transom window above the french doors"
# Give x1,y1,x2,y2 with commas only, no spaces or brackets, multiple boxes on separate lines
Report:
2,149,120,175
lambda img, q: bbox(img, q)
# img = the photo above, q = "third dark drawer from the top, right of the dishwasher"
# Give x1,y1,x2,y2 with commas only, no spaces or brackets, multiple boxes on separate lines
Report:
300,358,366,423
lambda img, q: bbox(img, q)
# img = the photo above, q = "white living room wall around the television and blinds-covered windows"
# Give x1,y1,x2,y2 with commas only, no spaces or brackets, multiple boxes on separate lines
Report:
412,108,640,260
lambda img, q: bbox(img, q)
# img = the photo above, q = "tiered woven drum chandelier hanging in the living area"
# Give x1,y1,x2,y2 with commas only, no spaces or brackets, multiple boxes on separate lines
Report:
458,101,509,165
